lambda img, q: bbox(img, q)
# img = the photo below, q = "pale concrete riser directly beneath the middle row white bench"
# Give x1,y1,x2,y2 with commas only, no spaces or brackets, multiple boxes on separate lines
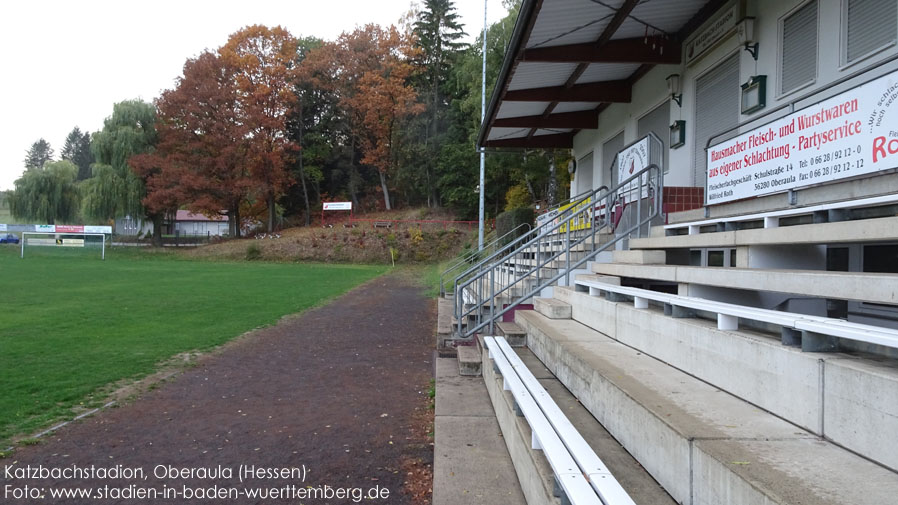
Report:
554,288,898,470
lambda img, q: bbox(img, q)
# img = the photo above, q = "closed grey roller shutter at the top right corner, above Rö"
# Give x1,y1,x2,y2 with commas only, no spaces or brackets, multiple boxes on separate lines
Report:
845,0,898,63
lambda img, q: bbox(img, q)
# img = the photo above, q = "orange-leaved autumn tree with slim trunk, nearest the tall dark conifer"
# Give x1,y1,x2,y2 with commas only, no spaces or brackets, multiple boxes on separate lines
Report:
300,24,425,210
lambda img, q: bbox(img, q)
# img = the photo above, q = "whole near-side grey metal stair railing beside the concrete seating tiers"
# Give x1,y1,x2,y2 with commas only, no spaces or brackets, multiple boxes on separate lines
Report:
455,164,664,339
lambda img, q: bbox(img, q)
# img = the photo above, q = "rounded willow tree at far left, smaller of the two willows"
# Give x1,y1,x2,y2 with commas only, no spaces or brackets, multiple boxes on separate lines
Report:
9,160,78,224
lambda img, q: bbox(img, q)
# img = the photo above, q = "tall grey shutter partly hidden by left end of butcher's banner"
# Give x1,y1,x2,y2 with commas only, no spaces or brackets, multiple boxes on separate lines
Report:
692,53,741,187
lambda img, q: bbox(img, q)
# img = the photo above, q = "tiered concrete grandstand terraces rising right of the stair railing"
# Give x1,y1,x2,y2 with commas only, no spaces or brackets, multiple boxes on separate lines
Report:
472,202,898,505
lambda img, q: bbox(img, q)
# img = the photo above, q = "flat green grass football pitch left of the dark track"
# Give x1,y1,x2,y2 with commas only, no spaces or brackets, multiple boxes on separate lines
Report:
0,246,386,449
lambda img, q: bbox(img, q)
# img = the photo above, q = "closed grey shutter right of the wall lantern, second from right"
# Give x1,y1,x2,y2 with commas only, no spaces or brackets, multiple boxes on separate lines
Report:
780,0,816,93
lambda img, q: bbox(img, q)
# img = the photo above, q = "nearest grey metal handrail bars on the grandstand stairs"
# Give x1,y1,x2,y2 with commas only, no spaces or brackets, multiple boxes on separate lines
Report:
455,164,664,338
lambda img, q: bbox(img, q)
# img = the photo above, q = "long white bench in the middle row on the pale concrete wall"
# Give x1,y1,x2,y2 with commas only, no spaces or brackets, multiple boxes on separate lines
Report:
575,279,898,348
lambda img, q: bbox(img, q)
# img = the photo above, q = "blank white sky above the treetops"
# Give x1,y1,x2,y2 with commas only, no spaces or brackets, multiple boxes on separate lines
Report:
0,0,505,190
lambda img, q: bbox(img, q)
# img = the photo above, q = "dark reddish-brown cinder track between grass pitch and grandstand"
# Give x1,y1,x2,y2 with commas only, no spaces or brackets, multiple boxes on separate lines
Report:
0,274,436,504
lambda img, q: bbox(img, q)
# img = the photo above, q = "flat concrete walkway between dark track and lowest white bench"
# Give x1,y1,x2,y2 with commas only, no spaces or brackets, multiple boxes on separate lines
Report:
433,358,526,505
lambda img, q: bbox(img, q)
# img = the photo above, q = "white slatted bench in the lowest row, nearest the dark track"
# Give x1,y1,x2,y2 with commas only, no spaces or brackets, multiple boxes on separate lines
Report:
484,337,635,505
